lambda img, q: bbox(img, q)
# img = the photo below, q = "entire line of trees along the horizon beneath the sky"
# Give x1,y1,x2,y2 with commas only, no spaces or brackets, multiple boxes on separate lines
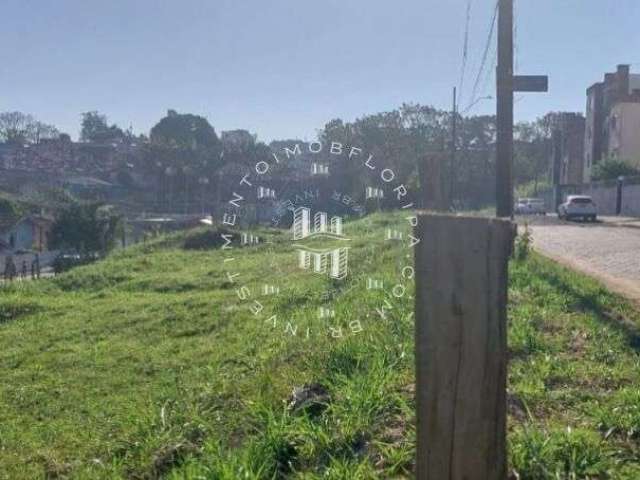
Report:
0,104,554,208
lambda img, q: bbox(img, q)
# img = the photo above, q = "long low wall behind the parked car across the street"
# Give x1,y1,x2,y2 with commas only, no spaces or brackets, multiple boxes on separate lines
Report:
539,177,640,217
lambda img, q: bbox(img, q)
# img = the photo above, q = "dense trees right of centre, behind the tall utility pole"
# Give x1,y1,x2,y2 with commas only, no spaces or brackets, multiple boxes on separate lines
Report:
320,104,553,208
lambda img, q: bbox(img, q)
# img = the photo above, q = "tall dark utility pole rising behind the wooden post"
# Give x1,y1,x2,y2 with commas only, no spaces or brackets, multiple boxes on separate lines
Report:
496,0,513,217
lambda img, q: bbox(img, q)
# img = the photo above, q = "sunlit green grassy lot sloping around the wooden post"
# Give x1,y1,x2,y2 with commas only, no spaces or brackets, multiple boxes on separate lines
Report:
0,216,640,480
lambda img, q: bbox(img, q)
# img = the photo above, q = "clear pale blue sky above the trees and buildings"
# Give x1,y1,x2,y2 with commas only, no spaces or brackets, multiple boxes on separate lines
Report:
0,0,640,140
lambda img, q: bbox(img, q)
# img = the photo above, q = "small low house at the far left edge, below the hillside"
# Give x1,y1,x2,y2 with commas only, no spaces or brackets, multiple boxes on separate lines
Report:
0,215,53,252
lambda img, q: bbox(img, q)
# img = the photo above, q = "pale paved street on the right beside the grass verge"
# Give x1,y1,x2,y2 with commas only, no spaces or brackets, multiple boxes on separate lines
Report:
517,216,640,303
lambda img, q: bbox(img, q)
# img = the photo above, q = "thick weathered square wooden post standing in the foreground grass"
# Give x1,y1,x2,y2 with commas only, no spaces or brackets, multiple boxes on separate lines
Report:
415,213,514,480
